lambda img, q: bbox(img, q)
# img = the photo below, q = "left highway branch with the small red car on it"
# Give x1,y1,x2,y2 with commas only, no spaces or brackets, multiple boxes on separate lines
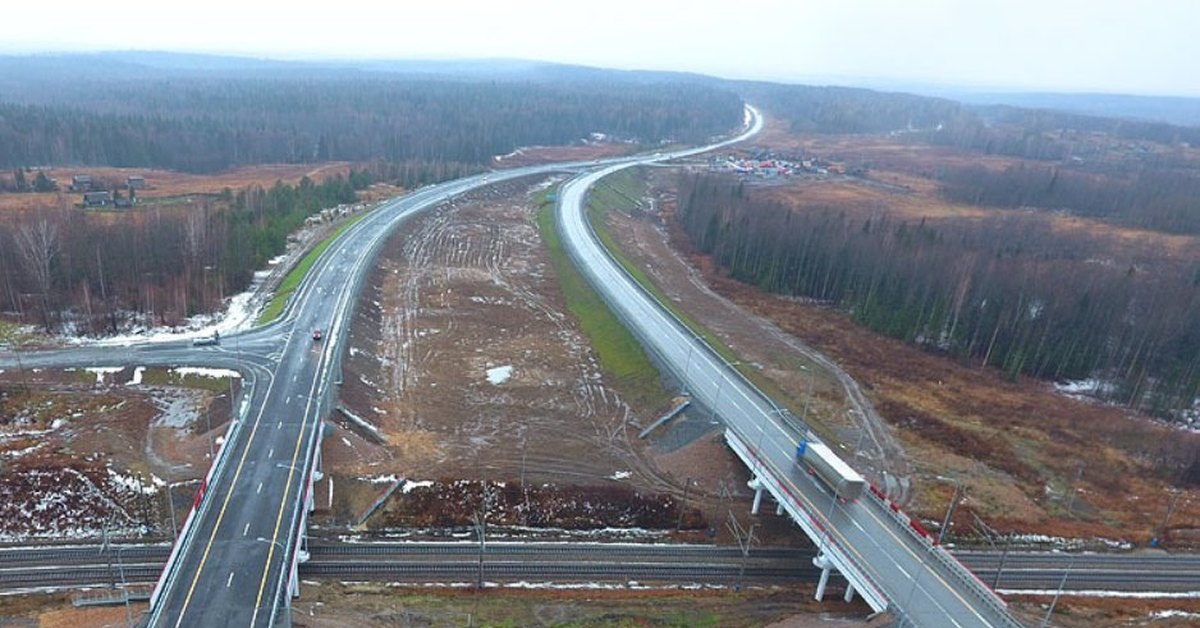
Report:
129,121,761,627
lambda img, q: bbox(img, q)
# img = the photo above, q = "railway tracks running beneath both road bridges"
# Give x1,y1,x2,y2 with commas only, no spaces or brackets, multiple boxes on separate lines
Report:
0,542,1200,593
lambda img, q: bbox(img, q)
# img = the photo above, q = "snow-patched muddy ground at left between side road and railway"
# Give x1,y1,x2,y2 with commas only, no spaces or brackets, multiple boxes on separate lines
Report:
0,367,236,543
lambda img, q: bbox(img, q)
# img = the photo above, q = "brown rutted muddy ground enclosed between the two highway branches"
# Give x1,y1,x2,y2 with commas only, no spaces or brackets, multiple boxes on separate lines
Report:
318,180,802,543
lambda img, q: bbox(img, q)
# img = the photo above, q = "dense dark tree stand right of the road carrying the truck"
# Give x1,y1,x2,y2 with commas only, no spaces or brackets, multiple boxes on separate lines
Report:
679,175,1200,415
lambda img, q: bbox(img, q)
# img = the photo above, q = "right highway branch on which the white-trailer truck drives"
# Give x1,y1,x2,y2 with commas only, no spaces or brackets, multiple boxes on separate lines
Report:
557,116,1016,627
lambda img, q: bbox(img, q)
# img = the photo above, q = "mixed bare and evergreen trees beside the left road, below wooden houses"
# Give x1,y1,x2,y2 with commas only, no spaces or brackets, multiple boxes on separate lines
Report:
0,169,384,335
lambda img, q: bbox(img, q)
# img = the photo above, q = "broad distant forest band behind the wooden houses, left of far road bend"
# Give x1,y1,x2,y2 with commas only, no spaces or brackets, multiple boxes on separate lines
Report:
0,77,742,173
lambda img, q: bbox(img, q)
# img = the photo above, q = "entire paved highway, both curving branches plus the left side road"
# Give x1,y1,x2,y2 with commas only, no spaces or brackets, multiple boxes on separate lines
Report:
0,107,1032,627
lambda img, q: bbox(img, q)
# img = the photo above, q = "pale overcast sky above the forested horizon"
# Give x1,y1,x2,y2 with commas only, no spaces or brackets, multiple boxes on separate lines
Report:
0,0,1200,96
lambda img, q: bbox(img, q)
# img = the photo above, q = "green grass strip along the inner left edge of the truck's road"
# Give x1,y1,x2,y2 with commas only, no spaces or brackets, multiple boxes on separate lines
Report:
538,192,671,409
